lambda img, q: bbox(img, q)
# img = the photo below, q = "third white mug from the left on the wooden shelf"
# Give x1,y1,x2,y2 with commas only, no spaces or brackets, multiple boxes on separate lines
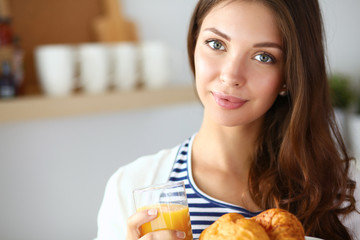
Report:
111,42,139,90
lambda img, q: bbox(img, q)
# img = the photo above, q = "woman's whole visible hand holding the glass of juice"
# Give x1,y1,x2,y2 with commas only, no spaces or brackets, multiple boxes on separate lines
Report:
126,208,186,240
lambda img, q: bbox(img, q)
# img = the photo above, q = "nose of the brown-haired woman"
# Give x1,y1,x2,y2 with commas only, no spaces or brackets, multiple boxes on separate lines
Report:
220,56,246,87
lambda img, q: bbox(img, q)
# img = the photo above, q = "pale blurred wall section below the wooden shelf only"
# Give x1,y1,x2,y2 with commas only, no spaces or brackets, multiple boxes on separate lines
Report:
0,103,202,240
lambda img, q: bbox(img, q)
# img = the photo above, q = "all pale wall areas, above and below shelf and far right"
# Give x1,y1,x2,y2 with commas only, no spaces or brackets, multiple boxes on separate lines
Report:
0,0,360,240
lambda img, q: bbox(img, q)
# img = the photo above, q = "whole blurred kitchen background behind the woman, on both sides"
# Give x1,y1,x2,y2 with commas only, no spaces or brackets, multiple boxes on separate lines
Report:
0,0,360,240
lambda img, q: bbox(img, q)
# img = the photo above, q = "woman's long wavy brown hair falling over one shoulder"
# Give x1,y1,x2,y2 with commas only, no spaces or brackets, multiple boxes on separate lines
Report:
188,0,357,239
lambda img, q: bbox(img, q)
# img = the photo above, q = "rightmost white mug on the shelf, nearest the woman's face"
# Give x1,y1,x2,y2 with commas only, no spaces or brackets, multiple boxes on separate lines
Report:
140,41,170,88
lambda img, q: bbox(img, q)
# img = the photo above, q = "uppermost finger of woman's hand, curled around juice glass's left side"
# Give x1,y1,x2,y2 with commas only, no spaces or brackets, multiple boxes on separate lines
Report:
126,208,157,240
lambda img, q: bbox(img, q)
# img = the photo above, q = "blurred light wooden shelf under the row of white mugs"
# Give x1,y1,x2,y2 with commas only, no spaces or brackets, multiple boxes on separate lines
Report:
0,86,197,123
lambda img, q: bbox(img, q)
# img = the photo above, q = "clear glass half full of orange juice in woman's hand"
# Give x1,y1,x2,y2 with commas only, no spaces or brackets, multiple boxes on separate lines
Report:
133,182,193,240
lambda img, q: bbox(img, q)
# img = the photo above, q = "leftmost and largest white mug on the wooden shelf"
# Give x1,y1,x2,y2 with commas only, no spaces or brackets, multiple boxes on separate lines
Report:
35,44,76,96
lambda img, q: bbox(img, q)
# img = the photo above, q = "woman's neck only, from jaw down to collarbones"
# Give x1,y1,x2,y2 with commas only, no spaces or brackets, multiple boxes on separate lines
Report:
193,111,260,176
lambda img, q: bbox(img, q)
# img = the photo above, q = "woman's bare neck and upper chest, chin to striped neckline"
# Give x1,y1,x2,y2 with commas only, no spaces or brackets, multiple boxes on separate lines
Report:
191,111,261,211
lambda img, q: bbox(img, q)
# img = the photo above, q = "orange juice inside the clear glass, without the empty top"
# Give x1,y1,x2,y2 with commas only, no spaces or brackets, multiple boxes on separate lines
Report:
138,203,193,240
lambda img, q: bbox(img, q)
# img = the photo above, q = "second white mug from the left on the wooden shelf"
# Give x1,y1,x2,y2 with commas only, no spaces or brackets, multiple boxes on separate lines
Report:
78,43,110,93
